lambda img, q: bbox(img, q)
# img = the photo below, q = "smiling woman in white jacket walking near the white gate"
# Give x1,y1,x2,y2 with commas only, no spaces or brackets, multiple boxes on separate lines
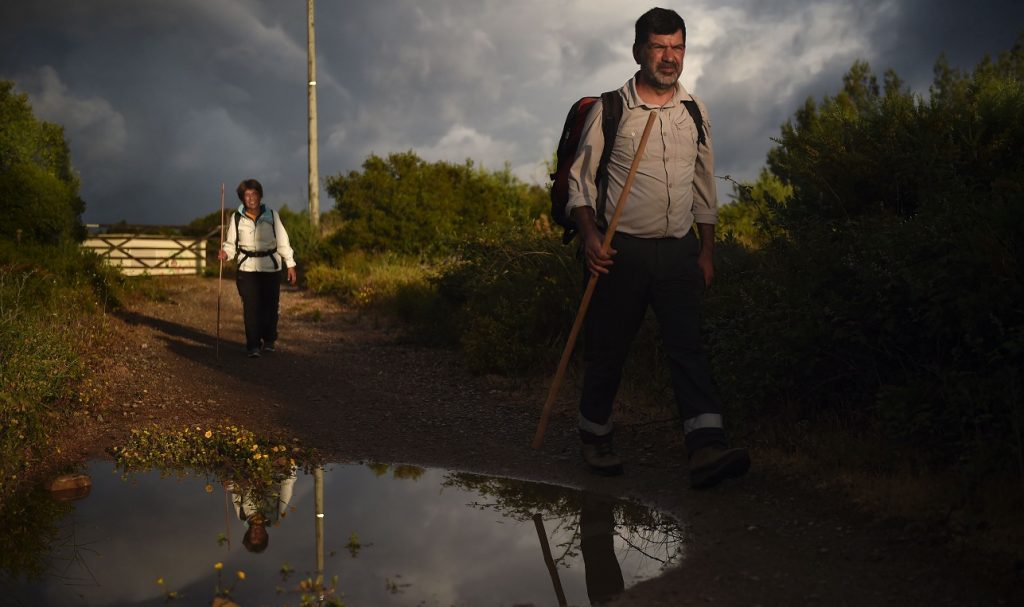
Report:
217,179,297,358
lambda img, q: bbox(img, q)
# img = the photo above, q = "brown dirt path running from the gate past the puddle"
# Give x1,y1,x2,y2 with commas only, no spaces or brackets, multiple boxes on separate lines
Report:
70,278,1024,606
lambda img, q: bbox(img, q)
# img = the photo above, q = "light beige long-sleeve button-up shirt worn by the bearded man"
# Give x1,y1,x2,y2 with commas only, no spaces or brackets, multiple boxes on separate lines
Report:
565,77,718,239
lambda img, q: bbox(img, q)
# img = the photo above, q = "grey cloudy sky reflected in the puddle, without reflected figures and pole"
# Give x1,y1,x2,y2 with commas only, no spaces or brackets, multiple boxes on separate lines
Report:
8,463,682,606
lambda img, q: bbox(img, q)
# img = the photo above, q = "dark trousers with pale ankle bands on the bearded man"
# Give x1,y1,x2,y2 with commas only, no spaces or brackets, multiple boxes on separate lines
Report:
580,230,726,453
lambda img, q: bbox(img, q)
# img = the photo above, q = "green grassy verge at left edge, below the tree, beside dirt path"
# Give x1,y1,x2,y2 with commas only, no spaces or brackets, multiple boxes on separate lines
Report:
0,236,145,502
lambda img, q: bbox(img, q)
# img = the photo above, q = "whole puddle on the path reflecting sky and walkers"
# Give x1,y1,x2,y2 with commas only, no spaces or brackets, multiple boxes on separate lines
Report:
6,462,683,607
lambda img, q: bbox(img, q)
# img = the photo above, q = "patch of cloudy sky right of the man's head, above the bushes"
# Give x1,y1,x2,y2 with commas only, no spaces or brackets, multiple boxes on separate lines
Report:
684,0,1024,200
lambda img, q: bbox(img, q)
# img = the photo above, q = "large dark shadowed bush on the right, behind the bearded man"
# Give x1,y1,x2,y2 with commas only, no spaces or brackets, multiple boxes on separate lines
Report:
708,46,1024,474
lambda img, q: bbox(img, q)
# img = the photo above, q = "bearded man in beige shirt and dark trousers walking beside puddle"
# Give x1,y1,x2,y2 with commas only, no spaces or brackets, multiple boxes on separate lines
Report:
566,8,751,487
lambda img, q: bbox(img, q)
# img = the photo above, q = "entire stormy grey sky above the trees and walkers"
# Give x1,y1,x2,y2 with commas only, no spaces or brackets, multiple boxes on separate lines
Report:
0,0,1024,223
